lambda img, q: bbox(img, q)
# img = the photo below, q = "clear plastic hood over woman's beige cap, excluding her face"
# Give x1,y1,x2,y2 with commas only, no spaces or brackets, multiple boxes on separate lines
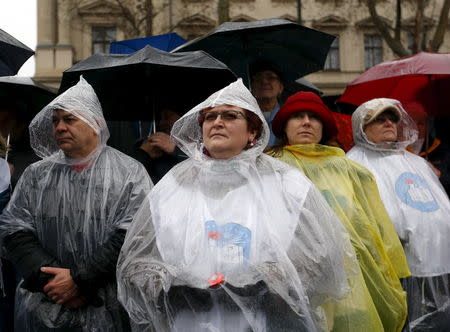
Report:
352,98,418,151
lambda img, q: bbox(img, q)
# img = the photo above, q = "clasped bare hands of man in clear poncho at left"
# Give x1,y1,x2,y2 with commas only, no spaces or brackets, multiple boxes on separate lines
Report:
41,266,80,304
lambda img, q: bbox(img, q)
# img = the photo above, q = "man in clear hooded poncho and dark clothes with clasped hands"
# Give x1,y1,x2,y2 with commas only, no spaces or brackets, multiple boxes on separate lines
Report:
0,78,152,332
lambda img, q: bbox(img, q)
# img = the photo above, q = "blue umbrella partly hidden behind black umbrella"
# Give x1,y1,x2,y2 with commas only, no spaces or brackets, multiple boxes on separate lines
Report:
109,32,186,54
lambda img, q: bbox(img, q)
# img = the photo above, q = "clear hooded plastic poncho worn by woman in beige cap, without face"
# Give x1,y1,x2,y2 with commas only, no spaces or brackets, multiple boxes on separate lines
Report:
347,99,450,277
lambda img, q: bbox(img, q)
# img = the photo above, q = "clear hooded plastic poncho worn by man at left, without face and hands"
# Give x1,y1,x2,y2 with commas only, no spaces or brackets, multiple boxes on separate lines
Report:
0,78,152,332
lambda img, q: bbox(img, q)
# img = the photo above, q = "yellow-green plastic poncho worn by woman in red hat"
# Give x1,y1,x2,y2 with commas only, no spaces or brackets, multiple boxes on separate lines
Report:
269,144,410,332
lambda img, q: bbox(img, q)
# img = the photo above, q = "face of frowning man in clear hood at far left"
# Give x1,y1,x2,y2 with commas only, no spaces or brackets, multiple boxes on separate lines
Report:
52,110,99,158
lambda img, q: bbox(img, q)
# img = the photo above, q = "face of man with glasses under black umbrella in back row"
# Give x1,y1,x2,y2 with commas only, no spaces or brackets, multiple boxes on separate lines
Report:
252,70,283,100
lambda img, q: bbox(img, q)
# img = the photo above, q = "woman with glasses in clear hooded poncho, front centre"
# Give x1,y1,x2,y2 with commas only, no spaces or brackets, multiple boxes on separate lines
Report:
117,79,355,331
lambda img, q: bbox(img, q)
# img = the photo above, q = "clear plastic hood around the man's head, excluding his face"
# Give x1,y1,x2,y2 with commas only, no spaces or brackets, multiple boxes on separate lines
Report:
29,76,109,164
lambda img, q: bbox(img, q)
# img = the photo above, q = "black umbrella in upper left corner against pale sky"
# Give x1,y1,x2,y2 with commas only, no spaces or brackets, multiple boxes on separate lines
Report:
0,29,34,76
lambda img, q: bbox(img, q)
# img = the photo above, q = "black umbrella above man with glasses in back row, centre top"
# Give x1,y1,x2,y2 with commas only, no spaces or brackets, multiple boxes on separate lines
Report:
172,19,336,85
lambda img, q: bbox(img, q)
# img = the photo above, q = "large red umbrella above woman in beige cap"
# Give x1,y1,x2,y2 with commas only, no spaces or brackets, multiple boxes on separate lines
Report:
338,52,450,116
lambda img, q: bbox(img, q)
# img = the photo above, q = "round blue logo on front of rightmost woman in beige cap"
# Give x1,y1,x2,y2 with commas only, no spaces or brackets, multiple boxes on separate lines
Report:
395,172,439,212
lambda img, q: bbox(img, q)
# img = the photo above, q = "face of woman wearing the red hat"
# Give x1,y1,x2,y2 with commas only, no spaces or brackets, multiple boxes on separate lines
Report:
285,111,323,145
